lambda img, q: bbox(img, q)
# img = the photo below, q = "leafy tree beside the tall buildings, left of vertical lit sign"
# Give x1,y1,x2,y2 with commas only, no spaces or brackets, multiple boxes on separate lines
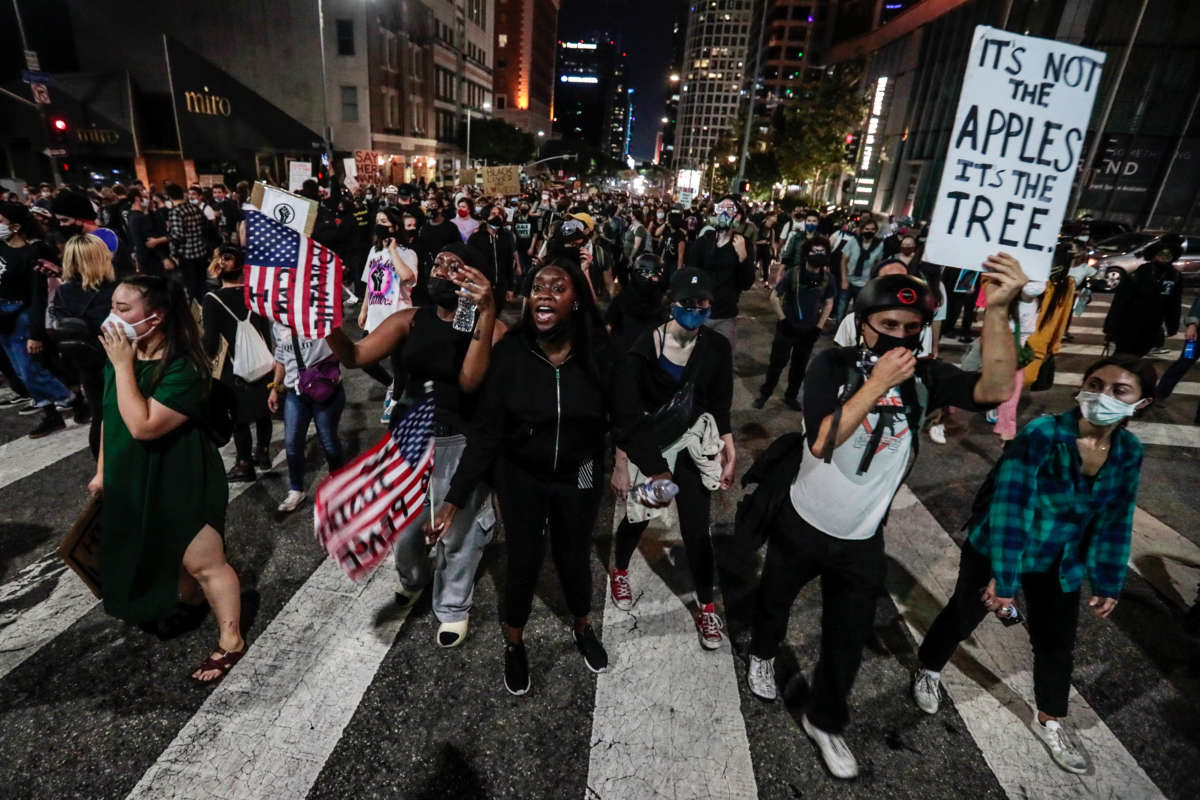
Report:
772,71,866,189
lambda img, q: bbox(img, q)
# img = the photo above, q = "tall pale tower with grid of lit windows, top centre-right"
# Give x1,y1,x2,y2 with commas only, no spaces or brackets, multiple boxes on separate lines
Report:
673,0,758,169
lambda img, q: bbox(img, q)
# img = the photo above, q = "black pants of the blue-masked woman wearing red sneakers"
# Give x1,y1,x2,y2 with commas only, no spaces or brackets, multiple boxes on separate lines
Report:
613,452,716,606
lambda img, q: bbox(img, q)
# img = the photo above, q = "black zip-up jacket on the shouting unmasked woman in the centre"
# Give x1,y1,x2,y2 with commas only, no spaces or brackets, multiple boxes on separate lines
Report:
446,329,610,507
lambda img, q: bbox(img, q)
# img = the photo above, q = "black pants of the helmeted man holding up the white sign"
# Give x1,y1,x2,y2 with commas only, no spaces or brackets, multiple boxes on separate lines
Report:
750,503,886,733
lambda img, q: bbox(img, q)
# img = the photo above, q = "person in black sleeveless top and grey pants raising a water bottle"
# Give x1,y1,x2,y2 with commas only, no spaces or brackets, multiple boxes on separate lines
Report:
325,243,506,648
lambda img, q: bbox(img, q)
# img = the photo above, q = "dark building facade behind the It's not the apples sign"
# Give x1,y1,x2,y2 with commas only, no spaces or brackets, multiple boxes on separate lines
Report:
828,0,1200,233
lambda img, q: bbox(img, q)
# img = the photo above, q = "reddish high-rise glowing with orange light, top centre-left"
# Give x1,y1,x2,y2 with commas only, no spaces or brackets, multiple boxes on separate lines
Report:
492,0,562,133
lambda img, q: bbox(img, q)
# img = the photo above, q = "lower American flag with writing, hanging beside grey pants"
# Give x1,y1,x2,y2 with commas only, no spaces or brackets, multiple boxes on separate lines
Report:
313,396,433,579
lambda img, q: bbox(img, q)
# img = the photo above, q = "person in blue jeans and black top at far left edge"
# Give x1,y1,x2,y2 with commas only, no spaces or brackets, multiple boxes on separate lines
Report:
0,197,76,439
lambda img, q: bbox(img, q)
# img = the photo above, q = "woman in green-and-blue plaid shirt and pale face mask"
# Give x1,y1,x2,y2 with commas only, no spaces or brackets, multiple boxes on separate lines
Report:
912,355,1157,774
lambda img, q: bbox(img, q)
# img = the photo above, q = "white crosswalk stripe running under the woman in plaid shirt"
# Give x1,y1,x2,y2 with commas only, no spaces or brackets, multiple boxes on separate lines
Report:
884,487,1163,800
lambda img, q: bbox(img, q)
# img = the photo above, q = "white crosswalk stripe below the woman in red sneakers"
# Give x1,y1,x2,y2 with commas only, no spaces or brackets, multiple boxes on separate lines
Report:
587,513,757,800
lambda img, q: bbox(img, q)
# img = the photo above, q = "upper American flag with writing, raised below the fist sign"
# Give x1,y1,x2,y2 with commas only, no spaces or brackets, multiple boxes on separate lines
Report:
246,209,342,339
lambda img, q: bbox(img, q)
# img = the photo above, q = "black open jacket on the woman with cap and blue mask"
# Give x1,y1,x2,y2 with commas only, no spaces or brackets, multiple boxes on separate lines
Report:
613,327,733,475
